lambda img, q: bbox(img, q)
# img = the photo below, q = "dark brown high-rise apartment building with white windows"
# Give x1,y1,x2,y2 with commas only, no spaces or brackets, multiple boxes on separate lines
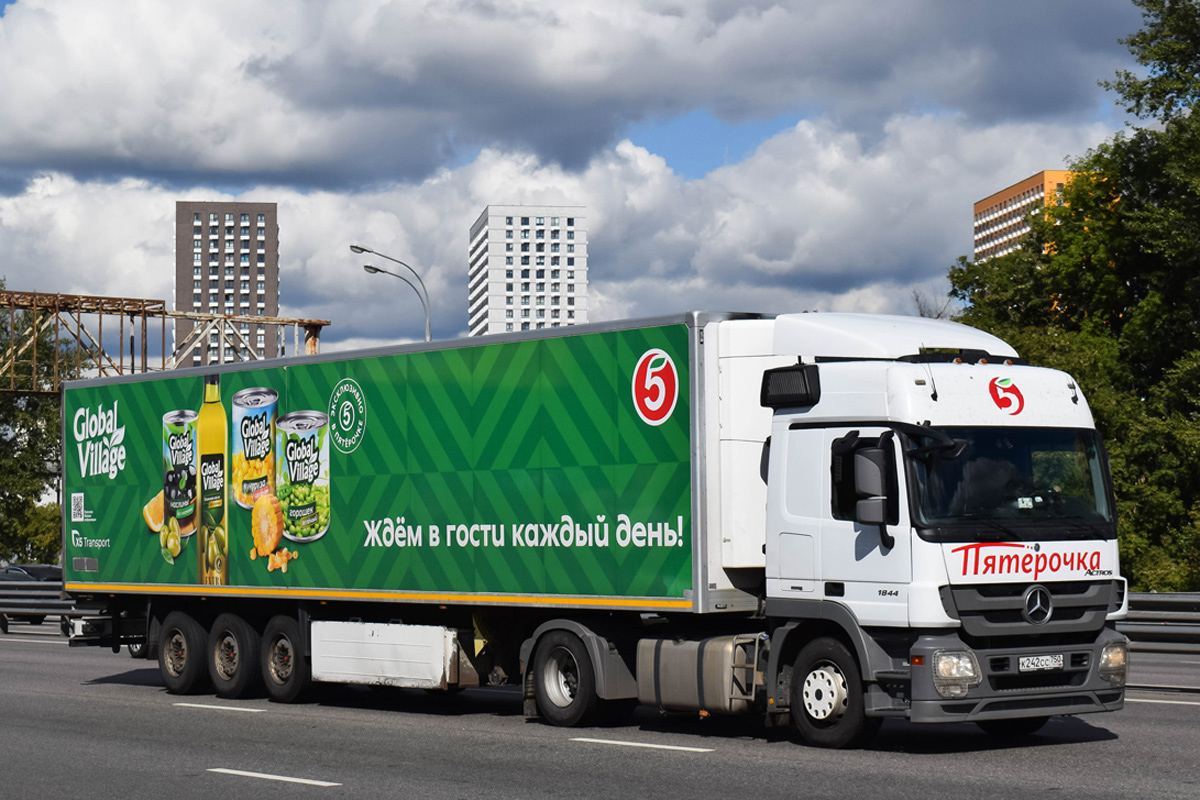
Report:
175,200,280,366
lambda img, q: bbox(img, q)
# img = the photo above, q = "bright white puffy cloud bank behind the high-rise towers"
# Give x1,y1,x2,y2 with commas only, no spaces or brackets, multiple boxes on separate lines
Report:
0,114,1106,349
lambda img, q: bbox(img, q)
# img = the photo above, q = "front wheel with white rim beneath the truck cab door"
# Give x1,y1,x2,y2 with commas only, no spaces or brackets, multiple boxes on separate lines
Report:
791,638,880,748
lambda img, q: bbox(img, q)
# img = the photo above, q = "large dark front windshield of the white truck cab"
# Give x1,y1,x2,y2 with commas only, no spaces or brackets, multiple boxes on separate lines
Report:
908,427,1112,535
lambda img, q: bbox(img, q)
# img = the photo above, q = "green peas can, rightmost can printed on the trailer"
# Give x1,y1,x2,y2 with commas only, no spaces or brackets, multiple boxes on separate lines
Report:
275,411,329,542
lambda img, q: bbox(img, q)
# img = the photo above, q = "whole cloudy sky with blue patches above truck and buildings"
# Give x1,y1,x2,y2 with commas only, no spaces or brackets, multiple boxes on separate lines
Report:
0,0,1141,350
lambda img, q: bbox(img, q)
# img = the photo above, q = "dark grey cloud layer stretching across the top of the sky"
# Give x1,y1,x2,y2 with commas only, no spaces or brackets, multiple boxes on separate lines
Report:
0,0,1139,185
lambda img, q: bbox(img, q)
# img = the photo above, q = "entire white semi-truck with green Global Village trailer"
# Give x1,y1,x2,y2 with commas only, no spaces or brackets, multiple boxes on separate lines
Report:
61,312,1128,747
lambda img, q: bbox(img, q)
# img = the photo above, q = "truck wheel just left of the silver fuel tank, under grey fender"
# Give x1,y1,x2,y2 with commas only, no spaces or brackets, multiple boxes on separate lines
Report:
533,631,599,728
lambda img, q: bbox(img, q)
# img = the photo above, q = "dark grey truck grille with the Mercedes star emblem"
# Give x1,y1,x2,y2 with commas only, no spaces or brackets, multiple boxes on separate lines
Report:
941,581,1120,638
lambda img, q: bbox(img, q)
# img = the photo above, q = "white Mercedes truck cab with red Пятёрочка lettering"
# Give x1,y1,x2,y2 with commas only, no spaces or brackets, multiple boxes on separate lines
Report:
762,314,1127,744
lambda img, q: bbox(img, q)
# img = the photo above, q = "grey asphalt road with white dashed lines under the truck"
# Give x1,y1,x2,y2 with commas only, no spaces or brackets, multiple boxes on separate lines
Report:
0,624,1200,800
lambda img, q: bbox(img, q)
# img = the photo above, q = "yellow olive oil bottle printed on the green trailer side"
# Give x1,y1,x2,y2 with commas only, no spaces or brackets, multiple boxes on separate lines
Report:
196,375,229,585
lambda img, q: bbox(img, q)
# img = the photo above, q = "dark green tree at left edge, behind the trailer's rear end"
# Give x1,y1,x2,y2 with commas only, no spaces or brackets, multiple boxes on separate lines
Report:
0,278,74,561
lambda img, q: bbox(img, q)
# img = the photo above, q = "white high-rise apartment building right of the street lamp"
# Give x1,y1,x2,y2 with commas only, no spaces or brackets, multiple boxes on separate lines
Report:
467,205,588,336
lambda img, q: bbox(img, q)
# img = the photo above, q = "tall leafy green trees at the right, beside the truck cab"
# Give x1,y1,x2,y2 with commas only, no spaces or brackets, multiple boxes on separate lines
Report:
949,0,1200,590
